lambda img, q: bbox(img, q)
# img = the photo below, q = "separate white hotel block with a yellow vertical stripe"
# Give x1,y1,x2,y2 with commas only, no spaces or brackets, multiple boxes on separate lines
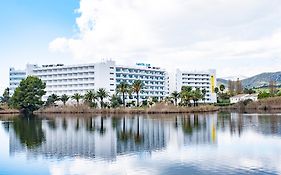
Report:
176,69,217,103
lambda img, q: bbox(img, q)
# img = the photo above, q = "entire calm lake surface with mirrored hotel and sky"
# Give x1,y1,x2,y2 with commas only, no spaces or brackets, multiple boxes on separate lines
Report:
0,113,281,175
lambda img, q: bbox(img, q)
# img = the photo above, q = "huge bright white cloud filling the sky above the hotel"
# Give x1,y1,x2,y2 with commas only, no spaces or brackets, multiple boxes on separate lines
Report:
49,0,281,75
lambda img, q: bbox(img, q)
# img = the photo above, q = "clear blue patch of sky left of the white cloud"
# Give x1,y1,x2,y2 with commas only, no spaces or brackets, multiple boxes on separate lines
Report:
0,0,79,92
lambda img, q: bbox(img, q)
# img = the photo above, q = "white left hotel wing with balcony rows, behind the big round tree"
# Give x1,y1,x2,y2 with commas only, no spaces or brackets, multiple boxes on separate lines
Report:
29,64,106,100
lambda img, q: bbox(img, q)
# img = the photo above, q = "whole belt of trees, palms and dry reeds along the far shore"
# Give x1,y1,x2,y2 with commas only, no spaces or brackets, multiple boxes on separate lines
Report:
3,76,281,114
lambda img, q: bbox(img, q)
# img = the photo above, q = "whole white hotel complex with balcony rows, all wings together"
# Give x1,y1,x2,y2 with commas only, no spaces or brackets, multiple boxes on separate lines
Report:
9,60,216,103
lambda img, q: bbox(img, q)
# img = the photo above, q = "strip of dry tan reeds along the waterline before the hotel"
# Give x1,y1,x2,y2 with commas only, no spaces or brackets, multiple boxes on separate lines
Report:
34,104,219,114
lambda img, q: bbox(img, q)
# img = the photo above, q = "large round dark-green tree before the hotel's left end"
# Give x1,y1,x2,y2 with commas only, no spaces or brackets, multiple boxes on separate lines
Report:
11,76,46,112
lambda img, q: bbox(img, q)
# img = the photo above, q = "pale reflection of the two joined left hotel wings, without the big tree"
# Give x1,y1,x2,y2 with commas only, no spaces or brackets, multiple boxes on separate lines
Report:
10,117,170,160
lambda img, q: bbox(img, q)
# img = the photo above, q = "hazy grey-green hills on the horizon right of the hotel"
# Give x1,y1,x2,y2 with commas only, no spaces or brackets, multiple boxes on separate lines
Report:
217,72,281,88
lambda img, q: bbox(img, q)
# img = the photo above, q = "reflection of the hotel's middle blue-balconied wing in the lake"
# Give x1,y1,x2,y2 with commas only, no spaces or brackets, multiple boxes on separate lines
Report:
114,117,169,154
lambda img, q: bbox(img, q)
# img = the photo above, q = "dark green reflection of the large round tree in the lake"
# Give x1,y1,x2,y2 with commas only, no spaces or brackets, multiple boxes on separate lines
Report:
12,116,45,148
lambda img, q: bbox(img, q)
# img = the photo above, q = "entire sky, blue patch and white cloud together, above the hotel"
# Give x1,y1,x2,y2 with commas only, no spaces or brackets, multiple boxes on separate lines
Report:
0,0,281,94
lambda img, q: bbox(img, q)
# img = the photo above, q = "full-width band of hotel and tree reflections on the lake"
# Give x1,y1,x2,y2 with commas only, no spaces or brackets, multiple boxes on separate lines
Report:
7,113,281,161
